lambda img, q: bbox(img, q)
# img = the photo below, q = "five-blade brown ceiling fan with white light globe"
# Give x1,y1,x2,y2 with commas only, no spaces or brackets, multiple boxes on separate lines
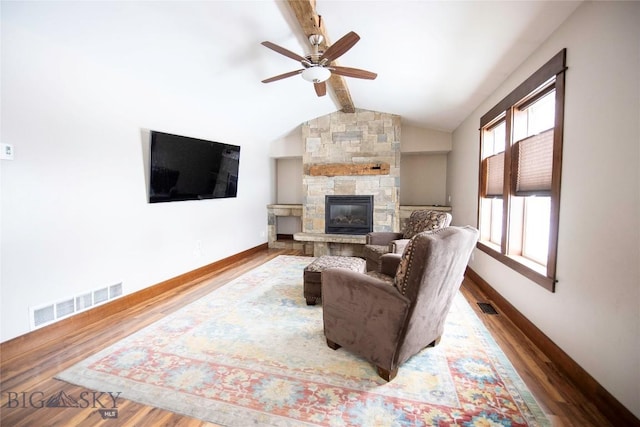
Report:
262,31,378,96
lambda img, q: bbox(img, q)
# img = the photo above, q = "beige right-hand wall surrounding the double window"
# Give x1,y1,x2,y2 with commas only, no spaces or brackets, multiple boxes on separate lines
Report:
448,2,640,416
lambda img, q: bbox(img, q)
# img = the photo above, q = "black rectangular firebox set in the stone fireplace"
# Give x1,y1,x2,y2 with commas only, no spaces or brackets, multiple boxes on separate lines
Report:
324,195,373,234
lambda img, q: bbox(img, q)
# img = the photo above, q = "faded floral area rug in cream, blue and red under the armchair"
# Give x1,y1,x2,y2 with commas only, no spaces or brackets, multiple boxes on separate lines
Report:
57,256,550,427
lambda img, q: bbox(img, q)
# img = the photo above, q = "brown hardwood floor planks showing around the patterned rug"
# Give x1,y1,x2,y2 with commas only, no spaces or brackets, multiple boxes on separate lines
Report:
0,249,624,427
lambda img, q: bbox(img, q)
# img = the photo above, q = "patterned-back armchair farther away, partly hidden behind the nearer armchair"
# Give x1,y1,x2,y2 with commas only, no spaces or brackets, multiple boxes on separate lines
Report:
363,210,451,271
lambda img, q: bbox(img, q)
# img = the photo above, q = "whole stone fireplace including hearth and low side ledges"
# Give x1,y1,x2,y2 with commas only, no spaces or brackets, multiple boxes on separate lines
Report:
267,110,451,256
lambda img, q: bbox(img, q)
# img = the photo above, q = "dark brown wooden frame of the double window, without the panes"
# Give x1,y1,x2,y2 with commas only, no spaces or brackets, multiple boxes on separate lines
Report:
477,49,567,292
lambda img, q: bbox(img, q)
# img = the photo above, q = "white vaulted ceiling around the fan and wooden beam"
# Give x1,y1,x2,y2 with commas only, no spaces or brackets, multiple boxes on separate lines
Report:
2,0,580,143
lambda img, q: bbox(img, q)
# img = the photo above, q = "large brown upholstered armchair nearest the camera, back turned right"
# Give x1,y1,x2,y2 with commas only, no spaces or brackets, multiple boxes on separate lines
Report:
322,227,479,381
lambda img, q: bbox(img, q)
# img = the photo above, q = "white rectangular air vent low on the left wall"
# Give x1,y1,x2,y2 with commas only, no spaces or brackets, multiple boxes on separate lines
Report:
30,283,122,330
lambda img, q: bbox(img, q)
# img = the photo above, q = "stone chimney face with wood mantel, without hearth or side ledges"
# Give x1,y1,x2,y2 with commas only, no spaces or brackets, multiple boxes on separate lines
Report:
302,110,400,234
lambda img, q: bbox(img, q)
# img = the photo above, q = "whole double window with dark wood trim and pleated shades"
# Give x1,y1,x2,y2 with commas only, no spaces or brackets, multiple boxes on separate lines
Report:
478,49,566,291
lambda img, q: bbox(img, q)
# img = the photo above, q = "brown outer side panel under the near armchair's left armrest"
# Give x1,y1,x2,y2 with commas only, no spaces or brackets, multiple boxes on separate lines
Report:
322,268,410,369
